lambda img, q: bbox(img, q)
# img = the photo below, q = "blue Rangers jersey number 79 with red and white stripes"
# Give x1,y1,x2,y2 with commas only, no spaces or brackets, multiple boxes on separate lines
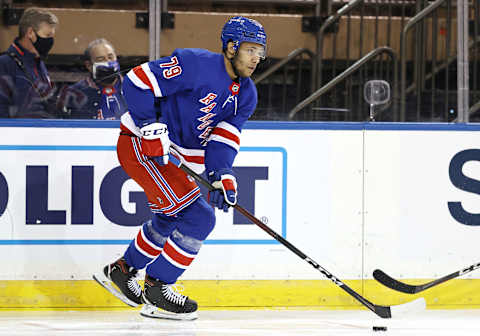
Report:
122,49,257,173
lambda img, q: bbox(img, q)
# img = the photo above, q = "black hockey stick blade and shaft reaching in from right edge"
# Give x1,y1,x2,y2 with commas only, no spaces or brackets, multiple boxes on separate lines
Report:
373,263,480,294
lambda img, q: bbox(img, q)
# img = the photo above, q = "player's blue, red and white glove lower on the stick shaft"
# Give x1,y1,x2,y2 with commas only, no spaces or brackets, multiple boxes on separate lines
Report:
208,169,237,212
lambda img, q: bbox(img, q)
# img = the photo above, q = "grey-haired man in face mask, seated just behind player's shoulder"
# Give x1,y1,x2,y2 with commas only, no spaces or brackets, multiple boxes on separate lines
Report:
59,38,127,119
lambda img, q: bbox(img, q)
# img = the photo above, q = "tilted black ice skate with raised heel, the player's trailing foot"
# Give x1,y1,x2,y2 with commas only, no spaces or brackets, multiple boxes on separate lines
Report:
93,258,142,307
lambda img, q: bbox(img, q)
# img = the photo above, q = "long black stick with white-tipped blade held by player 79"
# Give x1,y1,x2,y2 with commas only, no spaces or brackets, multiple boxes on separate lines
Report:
170,155,425,318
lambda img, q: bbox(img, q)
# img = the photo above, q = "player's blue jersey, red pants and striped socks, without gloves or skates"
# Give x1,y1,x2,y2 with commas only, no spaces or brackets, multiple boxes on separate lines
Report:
117,49,257,283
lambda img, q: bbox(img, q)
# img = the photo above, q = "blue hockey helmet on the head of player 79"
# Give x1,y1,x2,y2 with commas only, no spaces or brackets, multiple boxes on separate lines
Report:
221,16,267,55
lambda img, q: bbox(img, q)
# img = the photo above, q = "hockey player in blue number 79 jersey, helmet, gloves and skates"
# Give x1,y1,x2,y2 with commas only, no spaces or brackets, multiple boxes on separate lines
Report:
94,16,266,319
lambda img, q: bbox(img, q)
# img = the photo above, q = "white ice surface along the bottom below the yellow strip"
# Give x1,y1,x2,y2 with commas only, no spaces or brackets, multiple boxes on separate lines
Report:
0,309,480,336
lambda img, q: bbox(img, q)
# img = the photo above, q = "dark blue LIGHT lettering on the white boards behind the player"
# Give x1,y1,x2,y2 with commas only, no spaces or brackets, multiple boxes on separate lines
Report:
16,166,268,226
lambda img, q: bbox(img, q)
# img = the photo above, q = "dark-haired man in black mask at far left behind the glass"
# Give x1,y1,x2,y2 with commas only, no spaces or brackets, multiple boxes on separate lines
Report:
0,8,58,118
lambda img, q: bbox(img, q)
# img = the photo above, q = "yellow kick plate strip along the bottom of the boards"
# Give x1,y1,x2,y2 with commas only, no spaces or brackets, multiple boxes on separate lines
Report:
0,277,480,310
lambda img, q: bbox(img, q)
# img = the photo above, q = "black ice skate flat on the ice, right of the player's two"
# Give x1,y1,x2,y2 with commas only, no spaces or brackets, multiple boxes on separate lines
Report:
140,275,198,320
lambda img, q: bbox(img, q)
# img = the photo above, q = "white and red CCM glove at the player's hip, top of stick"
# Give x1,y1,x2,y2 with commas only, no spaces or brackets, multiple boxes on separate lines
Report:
140,122,170,166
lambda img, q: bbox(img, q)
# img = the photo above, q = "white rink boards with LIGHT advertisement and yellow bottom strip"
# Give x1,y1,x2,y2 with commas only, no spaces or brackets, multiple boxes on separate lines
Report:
0,120,480,308
